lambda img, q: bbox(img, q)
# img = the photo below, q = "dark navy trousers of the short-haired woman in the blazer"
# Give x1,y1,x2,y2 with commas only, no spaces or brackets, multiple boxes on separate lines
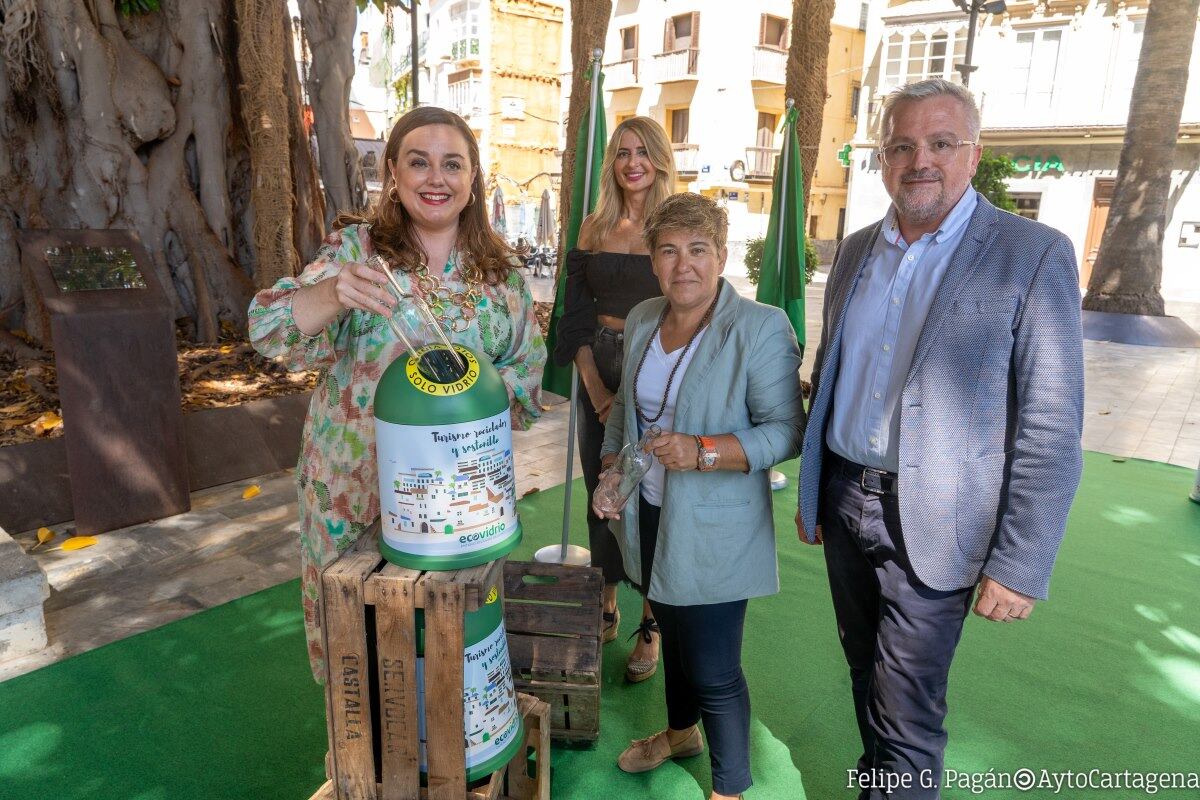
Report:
638,498,751,795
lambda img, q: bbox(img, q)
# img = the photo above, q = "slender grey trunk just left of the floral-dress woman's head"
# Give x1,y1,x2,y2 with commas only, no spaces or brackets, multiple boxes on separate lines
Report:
300,0,367,223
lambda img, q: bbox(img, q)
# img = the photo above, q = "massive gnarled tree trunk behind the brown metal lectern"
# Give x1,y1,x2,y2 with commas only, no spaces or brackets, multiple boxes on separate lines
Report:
0,0,324,341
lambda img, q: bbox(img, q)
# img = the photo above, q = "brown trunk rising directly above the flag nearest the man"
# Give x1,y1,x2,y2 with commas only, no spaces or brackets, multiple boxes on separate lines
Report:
784,0,835,209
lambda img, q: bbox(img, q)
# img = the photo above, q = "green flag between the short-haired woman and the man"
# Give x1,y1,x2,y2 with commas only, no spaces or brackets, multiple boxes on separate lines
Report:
755,102,804,348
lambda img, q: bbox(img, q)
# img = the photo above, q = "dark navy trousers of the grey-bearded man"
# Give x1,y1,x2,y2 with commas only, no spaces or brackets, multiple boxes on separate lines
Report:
821,457,973,800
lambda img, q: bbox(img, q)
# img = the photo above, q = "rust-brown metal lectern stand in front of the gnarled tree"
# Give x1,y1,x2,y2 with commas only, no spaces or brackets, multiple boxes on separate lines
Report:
18,230,191,534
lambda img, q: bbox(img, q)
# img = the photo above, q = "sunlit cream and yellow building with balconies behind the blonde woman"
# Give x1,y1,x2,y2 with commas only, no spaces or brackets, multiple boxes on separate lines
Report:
563,0,869,251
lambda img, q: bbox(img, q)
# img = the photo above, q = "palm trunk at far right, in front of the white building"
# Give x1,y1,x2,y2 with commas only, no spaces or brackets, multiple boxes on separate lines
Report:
1084,0,1200,317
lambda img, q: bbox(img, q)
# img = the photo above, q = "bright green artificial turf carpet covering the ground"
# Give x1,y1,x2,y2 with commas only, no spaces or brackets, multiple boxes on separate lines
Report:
0,453,1200,800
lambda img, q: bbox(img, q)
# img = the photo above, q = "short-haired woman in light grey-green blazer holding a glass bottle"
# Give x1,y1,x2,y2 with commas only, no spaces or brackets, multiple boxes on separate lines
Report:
596,194,804,800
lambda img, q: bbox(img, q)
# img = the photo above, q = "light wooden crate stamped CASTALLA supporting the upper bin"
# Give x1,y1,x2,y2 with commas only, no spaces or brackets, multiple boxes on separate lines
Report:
320,525,535,800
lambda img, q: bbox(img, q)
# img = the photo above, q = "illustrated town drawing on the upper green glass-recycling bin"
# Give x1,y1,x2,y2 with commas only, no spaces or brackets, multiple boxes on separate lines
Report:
388,450,516,535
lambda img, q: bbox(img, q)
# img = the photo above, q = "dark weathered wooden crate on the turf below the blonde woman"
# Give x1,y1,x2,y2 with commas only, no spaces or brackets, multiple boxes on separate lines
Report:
504,561,604,745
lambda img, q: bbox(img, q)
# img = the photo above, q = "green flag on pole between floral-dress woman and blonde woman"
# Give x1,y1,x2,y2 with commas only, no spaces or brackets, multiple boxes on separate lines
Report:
541,64,608,397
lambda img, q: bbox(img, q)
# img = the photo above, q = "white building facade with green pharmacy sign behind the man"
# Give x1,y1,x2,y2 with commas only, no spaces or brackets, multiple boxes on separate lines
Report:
847,0,1200,301
